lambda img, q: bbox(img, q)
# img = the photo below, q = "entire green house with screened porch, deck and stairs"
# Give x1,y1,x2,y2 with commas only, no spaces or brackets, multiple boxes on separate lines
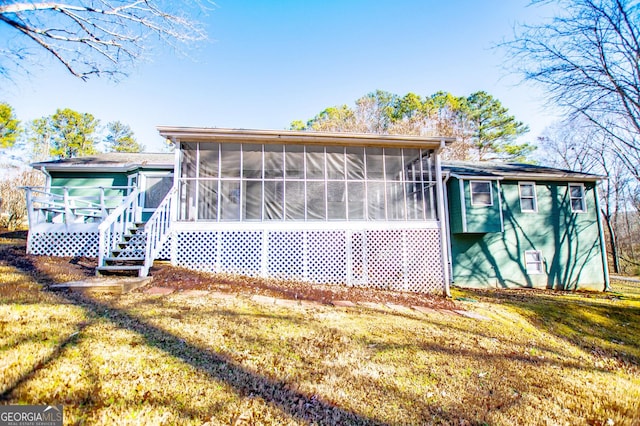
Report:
22,127,607,293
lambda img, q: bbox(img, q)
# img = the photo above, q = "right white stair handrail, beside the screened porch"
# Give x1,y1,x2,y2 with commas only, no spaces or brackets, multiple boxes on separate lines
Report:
140,185,178,277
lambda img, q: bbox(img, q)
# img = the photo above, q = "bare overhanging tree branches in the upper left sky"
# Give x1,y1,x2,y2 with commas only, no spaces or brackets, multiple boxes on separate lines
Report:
0,0,213,80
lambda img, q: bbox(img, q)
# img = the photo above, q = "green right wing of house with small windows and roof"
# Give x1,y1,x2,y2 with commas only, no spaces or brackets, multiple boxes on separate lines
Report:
443,162,608,290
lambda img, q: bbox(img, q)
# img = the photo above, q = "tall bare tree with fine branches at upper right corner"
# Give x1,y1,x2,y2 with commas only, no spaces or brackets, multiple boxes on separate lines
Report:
504,0,640,180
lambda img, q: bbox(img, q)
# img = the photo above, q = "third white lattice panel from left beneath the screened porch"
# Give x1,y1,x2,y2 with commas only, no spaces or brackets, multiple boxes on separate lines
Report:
267,231,307,280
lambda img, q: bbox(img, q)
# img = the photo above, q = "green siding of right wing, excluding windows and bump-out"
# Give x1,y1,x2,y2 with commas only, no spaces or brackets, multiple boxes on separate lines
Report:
451,181,604,290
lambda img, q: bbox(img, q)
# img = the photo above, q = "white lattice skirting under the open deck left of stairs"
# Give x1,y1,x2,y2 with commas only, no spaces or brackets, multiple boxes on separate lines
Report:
29,232,98,257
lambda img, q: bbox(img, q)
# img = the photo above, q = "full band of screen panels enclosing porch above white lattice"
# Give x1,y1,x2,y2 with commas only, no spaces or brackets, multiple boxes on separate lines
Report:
180,142,437,222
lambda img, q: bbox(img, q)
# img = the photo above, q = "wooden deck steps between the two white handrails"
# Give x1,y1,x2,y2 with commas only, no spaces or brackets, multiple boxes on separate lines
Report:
96,222,147,276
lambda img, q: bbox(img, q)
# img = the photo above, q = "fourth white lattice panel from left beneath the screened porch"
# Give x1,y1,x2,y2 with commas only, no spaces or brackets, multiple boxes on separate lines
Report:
307,231,347,284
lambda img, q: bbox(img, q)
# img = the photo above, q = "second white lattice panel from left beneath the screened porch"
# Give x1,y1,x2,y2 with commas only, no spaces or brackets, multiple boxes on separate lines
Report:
219,231,262,276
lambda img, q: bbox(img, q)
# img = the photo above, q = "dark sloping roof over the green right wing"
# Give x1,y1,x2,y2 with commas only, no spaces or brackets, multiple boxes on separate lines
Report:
442,161,606,181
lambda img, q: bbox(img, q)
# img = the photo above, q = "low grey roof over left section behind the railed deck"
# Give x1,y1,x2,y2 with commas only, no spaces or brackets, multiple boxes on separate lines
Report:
31,152,175,172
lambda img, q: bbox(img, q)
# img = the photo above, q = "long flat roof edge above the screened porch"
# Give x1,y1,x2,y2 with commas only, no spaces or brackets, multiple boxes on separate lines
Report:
158,126,456,149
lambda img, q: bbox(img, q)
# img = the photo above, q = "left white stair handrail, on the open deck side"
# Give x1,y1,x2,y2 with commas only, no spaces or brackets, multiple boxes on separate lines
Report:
98,188,140,266
